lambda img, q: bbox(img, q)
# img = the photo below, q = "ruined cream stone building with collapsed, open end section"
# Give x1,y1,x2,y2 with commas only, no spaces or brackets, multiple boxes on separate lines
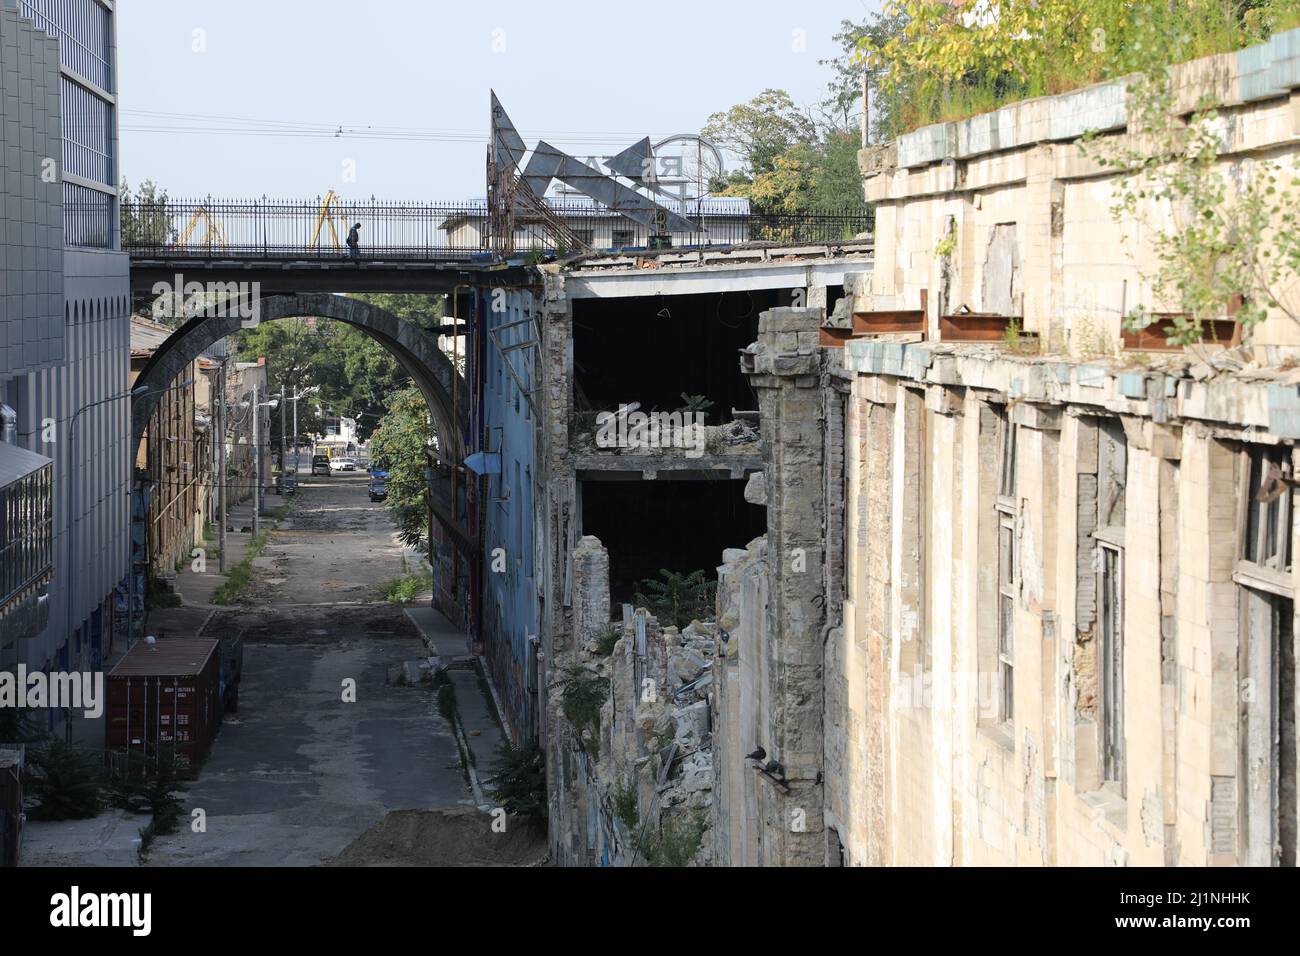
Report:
540,31,1300,866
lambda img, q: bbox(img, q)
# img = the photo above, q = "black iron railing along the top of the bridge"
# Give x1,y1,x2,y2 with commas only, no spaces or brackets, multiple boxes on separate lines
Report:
122,195,875,260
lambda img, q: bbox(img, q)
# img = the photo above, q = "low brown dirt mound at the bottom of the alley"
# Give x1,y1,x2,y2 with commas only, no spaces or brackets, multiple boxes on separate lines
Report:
326,806,546,866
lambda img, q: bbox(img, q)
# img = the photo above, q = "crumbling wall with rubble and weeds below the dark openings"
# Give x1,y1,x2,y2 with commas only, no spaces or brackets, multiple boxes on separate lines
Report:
549,536,719,866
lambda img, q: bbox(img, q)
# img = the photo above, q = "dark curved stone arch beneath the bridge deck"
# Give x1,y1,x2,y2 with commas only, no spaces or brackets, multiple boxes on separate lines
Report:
131,293,468,464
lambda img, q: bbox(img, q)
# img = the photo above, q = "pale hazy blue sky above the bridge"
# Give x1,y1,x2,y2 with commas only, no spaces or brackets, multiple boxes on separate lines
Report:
117,0,880,200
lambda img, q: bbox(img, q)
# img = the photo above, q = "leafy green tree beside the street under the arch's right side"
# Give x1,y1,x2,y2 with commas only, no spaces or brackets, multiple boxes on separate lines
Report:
371,386,434,550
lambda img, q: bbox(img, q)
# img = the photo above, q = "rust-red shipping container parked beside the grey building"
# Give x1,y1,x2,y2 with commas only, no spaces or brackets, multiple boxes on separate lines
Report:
107,637,221,767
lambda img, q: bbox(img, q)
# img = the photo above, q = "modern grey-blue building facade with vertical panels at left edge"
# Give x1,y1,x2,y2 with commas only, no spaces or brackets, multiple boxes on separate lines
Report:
0,0,131,686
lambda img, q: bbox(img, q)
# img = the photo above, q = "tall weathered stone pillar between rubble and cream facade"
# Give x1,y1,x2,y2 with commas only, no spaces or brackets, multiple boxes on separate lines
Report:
741,308,826,866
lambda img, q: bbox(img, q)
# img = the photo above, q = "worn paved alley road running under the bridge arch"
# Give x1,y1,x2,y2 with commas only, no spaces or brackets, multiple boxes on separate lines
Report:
150,472,469,866
